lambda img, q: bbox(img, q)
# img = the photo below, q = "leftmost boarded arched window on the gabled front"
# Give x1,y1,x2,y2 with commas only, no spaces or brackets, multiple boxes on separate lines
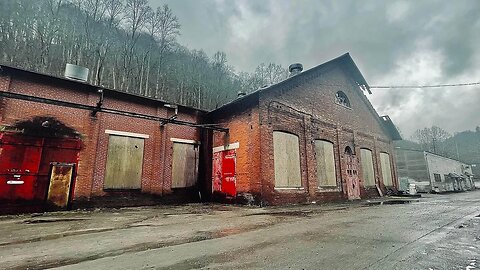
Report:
273,131,302,188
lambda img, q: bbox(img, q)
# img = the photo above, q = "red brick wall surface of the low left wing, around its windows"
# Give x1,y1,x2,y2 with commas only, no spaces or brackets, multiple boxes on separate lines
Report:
0,70,202,200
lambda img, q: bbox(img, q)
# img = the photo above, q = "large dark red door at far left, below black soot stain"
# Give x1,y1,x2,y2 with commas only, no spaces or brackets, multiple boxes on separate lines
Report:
0,133,80,205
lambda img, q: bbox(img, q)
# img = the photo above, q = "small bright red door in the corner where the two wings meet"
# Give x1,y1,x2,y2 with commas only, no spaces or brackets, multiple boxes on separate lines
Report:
213,150,237,197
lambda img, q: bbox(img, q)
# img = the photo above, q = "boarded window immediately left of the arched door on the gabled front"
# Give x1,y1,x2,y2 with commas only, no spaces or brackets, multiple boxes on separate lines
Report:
315,140,337,187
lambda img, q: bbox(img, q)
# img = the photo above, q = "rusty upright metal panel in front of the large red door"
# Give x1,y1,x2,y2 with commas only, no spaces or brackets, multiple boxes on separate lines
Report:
47,163,75,208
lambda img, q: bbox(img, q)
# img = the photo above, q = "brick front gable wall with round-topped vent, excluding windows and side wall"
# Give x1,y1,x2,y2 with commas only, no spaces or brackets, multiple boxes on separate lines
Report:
260,62,396,204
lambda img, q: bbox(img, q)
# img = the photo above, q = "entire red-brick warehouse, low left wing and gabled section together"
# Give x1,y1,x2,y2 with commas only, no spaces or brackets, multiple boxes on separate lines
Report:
0,54,401,212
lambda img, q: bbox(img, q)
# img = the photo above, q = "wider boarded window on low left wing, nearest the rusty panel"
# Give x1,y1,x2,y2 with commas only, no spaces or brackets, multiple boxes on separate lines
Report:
104,135,144,189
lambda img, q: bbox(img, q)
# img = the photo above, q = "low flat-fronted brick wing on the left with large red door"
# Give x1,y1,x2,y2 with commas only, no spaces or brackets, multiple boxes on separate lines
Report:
0,66,219,211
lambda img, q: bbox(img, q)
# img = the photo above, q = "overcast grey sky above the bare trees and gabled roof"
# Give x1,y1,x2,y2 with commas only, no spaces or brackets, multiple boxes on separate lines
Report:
150,0,480,138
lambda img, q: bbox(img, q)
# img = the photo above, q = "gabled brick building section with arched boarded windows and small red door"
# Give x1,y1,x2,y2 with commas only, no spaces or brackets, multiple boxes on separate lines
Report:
207,54,400,204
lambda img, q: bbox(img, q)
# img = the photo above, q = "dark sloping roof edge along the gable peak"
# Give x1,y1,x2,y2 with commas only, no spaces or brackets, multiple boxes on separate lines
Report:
209,53,372,114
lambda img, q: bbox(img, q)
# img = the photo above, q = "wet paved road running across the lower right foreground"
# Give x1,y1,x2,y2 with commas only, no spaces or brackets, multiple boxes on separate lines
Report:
54,191,480,269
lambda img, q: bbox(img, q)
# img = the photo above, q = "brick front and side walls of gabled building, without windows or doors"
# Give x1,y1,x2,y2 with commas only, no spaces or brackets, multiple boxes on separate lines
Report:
213,62,396,204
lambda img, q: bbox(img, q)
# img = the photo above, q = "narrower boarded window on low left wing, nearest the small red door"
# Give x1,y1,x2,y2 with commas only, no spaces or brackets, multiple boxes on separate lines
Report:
172,143,198,188
